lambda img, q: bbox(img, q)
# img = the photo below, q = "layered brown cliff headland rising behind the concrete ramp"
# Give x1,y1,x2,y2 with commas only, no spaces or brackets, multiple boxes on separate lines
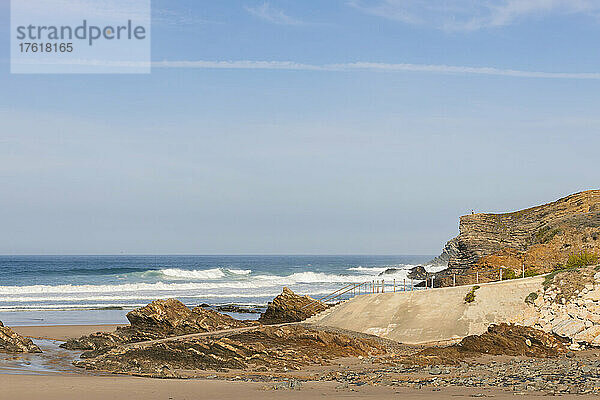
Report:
438,190,600,283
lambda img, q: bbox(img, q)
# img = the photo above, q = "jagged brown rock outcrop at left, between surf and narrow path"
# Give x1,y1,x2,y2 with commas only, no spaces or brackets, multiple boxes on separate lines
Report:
61,299,256,351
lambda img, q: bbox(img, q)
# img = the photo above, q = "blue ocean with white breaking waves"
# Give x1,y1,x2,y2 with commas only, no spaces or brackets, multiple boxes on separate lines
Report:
0,255,434,325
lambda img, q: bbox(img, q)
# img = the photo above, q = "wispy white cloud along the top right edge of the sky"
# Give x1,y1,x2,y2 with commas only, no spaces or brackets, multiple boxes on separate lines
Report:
348,0,600,30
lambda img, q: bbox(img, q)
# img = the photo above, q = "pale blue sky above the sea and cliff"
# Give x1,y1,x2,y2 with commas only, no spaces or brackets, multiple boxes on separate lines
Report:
0,0,600,254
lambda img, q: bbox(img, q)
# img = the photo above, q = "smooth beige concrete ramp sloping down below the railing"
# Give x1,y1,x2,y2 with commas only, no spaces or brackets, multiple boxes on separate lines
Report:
307,276,544,344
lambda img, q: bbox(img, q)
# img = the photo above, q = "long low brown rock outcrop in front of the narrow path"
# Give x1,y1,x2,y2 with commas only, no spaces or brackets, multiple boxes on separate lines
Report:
74,325,385,377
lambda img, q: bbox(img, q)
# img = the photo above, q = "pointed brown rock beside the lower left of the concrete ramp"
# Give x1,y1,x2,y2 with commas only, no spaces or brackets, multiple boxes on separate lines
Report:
258,287,329,325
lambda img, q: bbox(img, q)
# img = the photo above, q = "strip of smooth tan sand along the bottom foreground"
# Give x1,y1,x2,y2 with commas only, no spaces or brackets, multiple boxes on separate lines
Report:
0,375,585,400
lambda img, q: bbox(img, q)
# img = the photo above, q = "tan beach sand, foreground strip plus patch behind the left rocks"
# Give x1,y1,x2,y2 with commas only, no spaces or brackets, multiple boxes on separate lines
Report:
0,325,592,400
